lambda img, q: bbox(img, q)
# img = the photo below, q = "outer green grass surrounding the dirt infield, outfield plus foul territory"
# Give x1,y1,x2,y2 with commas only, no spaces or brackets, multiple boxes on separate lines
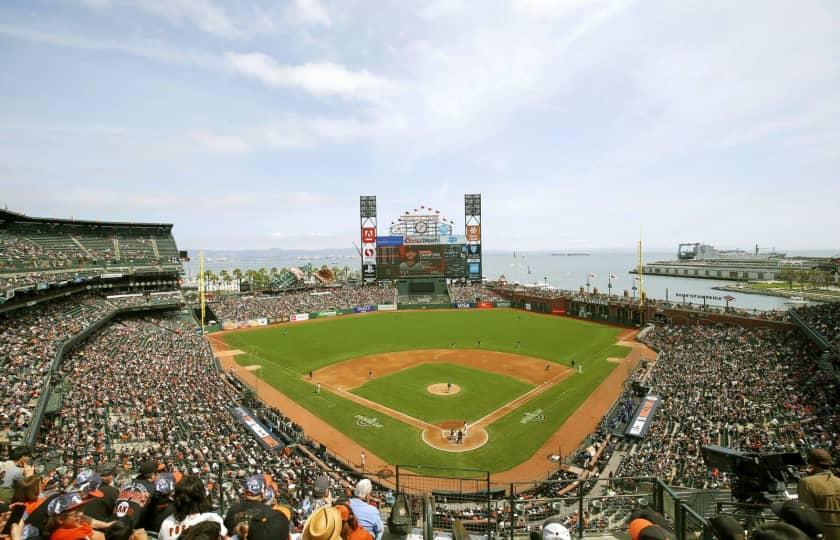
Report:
224,309,628,472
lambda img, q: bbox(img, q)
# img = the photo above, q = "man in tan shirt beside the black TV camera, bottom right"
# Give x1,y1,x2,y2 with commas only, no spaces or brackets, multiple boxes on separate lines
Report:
799,448,840,540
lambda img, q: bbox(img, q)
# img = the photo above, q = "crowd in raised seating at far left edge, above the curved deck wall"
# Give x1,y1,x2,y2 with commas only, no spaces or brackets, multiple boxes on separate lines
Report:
0,295,113,441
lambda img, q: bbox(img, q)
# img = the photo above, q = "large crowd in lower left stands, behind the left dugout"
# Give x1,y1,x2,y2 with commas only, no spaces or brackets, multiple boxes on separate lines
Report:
40,315,380,527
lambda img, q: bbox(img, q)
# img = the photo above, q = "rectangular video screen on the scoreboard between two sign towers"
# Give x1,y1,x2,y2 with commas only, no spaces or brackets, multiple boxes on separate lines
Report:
376,244,467,279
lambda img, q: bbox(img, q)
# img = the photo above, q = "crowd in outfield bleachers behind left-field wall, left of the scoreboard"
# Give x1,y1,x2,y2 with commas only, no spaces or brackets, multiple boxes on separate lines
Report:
209,284,396,321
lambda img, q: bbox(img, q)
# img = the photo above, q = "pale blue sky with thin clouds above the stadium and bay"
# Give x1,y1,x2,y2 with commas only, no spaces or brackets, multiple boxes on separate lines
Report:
0,0,840,250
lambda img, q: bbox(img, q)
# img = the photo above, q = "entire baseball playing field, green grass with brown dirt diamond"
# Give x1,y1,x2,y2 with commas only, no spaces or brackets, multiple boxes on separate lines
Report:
213,309,630,472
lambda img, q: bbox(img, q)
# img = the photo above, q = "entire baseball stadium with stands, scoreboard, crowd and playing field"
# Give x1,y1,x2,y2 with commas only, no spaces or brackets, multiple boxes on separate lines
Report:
0,194,840,540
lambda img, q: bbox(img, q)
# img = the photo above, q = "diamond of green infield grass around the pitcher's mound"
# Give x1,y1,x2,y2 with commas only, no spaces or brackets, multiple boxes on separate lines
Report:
353,364,533,424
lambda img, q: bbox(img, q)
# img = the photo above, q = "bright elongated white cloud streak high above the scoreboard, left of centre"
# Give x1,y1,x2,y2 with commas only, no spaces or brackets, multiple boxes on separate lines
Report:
225,52,388,99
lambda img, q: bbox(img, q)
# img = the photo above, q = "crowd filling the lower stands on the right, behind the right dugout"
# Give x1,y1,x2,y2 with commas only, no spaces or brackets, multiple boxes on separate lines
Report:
617,326,840,488
